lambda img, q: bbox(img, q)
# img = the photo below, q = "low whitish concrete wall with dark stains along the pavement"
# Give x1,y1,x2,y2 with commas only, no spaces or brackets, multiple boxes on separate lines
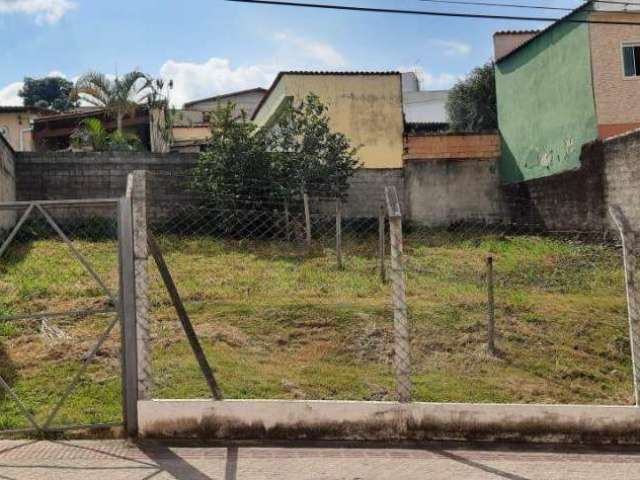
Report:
138,400,640,443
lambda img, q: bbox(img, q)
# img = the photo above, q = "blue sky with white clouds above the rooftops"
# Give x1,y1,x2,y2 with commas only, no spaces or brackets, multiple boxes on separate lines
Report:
0,0,579,106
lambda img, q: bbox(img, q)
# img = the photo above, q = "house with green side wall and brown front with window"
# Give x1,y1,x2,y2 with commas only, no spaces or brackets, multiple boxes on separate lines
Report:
494,2,640,183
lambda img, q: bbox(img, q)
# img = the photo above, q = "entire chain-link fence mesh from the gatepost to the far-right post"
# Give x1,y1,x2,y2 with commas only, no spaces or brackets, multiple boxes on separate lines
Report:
144,175,633,404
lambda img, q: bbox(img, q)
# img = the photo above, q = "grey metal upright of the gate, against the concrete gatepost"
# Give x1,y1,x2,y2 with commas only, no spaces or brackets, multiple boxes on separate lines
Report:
118,197,138,437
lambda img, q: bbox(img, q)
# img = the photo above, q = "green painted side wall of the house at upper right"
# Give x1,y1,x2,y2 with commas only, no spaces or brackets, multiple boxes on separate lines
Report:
496,12,598,183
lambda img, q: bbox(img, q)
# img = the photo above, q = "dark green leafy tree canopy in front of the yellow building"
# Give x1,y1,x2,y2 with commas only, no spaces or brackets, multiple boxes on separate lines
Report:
193,95,358,205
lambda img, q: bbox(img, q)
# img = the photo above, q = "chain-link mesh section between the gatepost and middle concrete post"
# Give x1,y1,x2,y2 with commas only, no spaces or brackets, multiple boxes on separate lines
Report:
149,172,395,400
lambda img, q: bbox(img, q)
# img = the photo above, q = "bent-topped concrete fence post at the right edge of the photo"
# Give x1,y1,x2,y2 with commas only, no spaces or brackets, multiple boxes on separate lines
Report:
609,206,640,406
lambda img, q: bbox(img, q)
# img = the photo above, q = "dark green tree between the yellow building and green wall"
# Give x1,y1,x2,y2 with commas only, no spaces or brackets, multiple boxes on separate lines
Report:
446,62,498,132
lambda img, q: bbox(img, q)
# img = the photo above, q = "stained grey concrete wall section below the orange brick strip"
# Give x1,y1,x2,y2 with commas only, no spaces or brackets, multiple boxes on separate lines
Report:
405,158,505,226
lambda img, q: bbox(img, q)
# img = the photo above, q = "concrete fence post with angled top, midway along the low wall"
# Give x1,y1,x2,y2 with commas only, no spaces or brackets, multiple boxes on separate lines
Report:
385,187,411,402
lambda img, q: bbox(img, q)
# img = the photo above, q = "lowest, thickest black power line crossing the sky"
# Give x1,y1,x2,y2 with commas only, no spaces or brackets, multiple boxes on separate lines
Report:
226,0,640,26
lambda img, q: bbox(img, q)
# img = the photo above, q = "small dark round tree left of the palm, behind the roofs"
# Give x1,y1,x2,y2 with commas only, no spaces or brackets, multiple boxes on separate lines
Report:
18,77,78,112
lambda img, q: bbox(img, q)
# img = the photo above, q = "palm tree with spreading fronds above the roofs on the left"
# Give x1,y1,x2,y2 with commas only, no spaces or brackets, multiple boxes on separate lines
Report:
71,70,148,132
